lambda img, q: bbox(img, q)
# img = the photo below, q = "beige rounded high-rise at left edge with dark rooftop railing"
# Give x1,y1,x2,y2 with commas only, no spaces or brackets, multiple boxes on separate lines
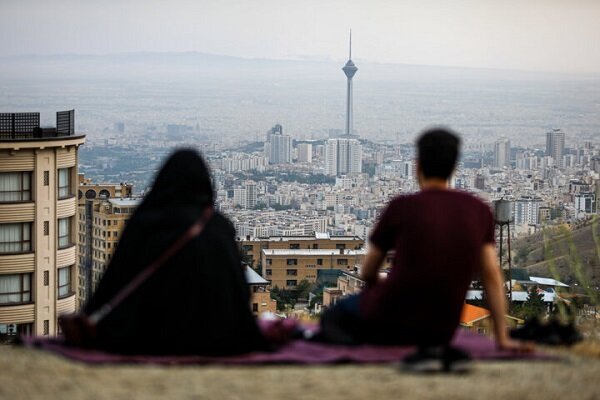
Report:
0,110,85,335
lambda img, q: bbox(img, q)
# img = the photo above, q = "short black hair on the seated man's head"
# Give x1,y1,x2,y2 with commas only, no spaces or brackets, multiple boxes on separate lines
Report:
417,128,460,179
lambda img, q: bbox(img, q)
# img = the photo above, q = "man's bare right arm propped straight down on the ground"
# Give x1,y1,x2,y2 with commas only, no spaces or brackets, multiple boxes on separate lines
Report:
481,243,533,351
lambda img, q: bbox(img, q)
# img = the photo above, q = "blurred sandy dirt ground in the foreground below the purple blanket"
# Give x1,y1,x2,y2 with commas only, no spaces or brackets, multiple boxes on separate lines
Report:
0,346,600,400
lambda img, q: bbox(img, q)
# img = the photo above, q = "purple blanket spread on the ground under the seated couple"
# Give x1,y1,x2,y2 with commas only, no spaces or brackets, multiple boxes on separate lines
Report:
18,329,552,365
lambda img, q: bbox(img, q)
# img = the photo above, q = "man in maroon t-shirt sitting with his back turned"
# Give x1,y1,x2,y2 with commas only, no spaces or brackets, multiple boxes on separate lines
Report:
321,129,528,356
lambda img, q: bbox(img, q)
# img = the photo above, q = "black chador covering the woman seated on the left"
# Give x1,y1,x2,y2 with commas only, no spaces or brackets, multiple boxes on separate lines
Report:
84,150,265,355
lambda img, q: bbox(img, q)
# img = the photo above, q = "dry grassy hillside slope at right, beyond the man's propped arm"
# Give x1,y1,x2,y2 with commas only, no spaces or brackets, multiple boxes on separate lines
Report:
512,218,600,287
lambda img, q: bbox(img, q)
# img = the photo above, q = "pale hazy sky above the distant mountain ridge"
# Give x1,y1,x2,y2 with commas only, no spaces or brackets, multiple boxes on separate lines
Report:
0,0,600,73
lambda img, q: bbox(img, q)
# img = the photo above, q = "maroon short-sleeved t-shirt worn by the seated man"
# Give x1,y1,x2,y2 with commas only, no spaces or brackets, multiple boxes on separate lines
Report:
360,189,494,344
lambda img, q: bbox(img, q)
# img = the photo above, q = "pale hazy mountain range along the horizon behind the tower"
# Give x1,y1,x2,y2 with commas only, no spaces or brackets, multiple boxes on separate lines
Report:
0,52,598,82
